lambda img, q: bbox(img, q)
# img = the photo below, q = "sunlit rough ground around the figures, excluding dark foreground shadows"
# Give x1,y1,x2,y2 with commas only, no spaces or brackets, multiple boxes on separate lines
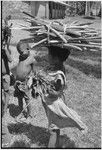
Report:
2,17,101,148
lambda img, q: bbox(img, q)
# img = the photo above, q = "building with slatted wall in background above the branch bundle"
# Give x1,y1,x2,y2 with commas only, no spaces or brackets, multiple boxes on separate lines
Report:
30,1,70,19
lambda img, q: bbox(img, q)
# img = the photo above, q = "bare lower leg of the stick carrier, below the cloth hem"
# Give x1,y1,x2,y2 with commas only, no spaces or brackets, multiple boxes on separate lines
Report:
48,129,60,148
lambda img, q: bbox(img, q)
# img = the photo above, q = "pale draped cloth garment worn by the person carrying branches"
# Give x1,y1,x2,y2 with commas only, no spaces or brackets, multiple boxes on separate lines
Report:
42,71,87,130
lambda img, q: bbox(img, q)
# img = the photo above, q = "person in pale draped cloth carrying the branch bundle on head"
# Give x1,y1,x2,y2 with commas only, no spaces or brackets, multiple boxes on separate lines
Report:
37,46,87,148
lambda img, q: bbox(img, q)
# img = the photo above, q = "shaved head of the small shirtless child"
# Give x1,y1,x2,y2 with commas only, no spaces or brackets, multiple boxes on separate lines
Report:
17,41,30,55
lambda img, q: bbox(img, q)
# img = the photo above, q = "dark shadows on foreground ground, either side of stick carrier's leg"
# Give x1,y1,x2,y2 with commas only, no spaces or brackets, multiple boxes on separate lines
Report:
8,123,75,148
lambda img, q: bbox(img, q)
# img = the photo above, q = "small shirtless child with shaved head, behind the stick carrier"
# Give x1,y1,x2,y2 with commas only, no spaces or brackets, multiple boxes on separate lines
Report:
14,41,36,120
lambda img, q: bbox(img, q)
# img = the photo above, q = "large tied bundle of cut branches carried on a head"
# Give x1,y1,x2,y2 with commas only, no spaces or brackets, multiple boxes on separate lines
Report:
18,12,101,51
